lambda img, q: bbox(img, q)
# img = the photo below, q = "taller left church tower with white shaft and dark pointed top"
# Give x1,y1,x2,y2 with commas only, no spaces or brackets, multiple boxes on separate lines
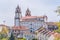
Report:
15,5,22,26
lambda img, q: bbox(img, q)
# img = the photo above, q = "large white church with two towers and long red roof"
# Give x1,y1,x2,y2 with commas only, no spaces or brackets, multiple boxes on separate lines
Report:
15,6,47,31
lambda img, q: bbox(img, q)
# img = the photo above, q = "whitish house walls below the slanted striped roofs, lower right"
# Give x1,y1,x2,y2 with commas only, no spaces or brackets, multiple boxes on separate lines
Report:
35,32,54,40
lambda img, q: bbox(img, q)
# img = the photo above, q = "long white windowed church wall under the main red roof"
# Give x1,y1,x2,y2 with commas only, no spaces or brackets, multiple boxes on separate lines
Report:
20,21,44,31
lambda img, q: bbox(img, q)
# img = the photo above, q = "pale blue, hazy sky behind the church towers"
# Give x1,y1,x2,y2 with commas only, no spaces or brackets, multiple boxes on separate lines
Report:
0,0,60,26
